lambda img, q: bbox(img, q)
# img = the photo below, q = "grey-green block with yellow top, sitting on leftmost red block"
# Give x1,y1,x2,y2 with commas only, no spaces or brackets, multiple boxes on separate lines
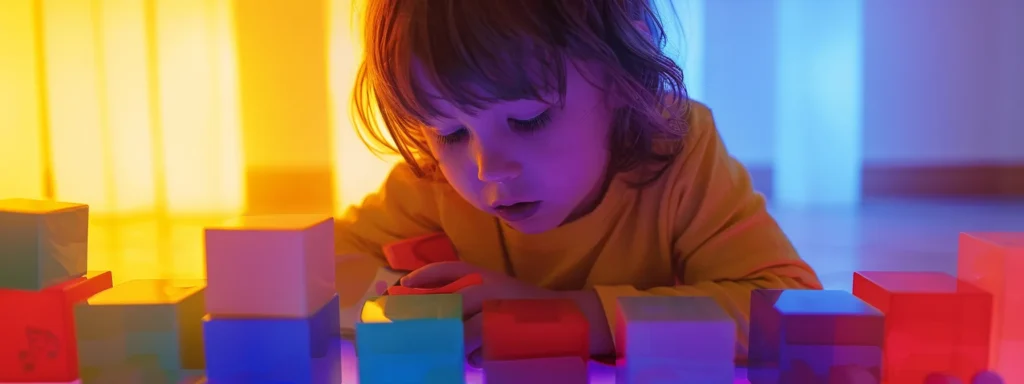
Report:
0,199,89,291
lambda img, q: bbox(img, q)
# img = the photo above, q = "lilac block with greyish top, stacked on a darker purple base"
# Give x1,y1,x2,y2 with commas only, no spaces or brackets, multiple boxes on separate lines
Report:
614,296,736,384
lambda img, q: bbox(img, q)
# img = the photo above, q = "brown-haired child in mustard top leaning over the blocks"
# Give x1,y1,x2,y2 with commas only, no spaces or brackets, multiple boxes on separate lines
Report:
336,0,821,361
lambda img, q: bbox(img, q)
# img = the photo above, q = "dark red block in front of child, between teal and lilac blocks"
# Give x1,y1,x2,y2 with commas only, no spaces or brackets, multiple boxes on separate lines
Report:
483,299,590,361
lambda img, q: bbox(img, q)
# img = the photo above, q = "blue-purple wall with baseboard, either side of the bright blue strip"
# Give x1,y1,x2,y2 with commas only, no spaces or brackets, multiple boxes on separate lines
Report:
700,0,1024,196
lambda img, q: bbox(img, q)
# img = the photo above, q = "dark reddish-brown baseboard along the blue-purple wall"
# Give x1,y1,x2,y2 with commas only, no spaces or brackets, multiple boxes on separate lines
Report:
748,164,1024,199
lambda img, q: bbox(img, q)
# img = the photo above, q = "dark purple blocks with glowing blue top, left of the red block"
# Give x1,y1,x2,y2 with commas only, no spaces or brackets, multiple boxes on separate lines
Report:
748,290,885,384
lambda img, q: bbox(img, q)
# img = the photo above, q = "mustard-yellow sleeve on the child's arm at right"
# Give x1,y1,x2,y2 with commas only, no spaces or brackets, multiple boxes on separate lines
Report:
595,102,821,360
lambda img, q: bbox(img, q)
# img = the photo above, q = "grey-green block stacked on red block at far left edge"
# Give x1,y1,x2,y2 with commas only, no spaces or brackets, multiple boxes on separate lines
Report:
0,199,113,383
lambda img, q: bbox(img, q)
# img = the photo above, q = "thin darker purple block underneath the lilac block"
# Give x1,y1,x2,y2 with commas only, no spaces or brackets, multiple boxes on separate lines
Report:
615,356,735,384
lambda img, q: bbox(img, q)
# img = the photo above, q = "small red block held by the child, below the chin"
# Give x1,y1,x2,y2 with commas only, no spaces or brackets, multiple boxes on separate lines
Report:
384,232,459,270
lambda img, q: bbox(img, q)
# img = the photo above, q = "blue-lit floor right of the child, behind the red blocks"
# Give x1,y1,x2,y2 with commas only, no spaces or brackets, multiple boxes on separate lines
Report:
772,200,1024,290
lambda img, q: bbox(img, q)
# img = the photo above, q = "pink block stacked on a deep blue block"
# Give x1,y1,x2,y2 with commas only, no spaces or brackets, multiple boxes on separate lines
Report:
203,215,341,384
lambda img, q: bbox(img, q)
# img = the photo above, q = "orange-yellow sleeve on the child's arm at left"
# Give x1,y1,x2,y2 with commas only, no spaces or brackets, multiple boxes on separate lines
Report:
334,163,441,336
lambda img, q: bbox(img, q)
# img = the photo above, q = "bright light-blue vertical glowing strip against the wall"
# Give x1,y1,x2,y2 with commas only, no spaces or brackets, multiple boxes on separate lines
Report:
773,0,863,205
